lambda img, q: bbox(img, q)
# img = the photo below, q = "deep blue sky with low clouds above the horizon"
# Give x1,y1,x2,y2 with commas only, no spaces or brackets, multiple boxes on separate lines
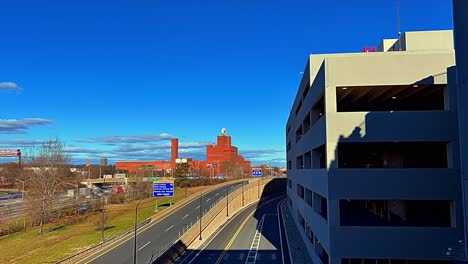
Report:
0,0,453,165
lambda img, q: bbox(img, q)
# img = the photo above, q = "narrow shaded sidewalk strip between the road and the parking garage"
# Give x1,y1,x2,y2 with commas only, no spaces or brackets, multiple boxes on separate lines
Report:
281,203,314,263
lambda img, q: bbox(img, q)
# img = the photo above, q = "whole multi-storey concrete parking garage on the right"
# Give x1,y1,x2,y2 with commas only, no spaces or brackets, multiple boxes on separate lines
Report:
286,29,467,264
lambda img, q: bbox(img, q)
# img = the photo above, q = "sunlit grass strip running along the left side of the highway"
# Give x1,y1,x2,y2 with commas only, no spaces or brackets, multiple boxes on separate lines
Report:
0,187,205,263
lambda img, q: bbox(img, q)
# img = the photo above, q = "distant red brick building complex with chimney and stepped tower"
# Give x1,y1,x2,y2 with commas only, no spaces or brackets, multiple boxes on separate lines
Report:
116,129,251,177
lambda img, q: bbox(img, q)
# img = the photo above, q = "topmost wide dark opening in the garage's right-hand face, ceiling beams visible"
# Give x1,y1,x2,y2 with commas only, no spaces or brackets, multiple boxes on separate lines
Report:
336,84,447,112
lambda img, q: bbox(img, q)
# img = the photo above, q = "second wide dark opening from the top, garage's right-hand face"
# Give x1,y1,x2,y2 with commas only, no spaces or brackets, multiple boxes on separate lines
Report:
338,142,448,169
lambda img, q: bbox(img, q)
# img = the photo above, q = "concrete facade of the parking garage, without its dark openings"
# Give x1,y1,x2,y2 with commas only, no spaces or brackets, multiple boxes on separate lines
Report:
286,31,463,263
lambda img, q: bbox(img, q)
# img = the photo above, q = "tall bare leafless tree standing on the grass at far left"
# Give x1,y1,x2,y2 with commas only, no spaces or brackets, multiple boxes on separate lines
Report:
26,139,70,235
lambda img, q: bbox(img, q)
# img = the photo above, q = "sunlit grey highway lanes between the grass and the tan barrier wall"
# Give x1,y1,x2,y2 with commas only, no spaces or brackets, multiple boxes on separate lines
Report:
80,183,242,264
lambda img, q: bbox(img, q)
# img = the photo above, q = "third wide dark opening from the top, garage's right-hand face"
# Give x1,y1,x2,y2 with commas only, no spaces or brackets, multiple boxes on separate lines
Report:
340,200,453,227
